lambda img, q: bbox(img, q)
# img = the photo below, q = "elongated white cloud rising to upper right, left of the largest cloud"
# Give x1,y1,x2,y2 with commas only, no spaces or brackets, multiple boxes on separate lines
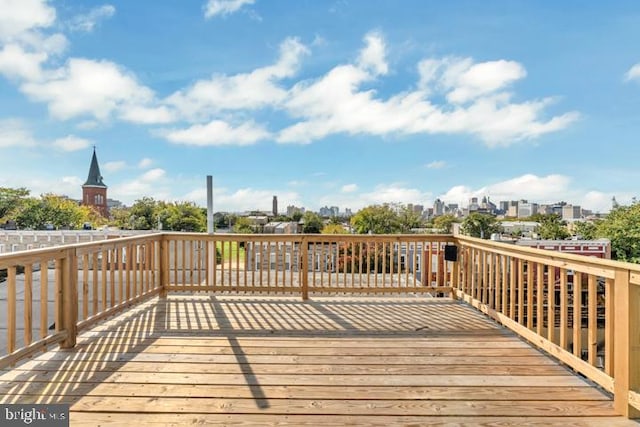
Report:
166,38,309,119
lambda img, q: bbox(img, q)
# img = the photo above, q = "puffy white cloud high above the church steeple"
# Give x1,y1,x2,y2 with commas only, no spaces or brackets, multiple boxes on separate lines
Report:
21,58,160,120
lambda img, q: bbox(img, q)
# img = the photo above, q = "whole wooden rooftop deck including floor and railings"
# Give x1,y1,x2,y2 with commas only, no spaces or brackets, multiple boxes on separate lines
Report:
0,233,640,426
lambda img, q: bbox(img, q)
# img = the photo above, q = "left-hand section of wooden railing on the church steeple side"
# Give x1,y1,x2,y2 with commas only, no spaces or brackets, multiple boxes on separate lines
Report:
0,235,161,369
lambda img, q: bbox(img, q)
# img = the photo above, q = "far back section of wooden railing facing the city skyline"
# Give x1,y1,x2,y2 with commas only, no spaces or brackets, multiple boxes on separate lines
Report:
163,233,455,299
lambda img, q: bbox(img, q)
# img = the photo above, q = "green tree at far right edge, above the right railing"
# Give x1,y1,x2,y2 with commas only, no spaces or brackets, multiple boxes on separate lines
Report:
597,202,640,263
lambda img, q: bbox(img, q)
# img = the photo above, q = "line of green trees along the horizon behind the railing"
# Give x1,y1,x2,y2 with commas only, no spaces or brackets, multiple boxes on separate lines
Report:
0,187,640,263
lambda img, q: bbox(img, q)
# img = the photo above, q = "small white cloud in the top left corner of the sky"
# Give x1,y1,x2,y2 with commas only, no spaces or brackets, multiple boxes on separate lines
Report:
0,0,56,40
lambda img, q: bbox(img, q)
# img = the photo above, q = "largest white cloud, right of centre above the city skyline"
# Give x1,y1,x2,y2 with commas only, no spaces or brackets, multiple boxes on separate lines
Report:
277,33,579,146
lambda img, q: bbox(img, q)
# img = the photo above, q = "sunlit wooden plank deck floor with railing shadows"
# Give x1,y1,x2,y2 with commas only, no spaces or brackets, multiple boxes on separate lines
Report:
0,295,638,426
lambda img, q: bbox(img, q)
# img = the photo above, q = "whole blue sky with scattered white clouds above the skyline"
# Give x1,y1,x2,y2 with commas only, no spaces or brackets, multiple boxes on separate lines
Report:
0,0,640,211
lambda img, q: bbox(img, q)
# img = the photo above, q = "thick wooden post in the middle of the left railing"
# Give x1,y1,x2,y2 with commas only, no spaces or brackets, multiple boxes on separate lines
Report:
58,249,78,348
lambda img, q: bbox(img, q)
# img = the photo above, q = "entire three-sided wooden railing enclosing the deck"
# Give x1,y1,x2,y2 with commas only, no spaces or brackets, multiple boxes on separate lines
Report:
0,233,640,417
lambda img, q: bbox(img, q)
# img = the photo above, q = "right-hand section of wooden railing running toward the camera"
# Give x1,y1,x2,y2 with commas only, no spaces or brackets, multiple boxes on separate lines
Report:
457,237,640,417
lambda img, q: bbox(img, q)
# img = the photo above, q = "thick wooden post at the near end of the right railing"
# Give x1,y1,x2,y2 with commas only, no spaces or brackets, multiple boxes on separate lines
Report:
613,269,640,418
